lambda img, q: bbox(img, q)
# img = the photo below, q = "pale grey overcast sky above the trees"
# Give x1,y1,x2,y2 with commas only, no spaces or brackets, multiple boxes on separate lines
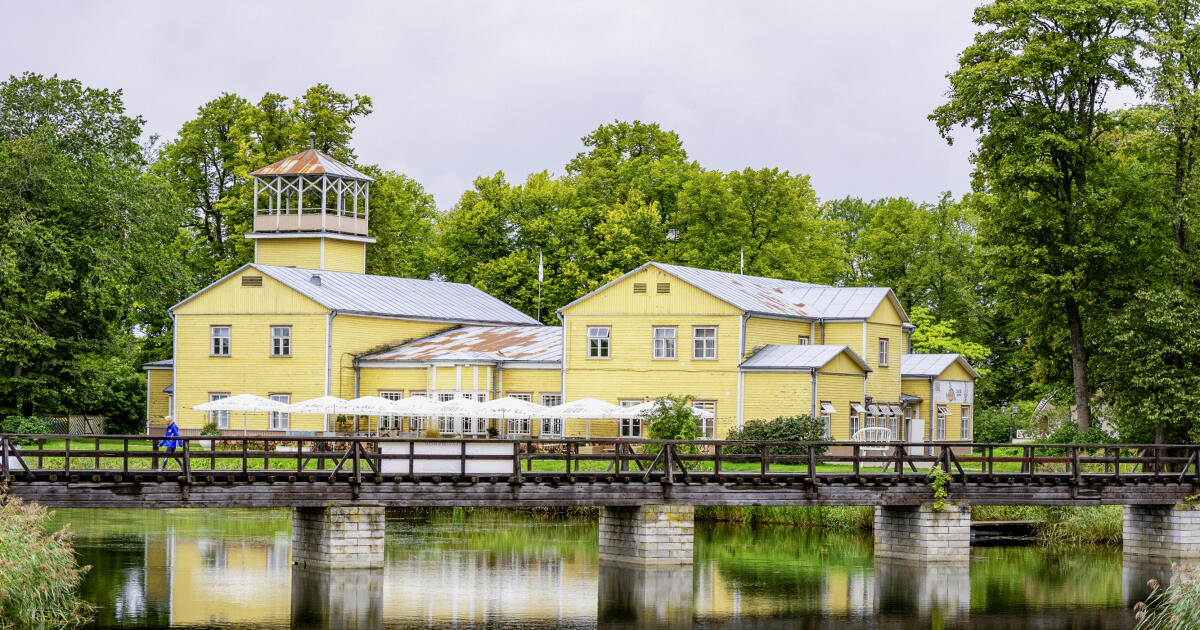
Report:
0,0,976,208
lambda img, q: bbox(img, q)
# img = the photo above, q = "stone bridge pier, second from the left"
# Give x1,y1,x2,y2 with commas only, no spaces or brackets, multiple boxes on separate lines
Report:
600,505,696,565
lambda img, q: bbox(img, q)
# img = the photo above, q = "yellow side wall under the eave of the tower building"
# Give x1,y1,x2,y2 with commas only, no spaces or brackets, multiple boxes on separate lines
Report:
322,314,454,398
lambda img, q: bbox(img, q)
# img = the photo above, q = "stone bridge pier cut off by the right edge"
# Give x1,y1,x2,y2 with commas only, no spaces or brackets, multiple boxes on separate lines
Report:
1122,504,1200,558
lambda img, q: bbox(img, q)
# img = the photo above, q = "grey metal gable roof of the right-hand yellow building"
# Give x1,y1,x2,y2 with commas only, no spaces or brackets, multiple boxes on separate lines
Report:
562,262,908,322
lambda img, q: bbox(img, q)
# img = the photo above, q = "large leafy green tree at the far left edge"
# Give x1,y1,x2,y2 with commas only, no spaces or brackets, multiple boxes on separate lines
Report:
0,74,186,415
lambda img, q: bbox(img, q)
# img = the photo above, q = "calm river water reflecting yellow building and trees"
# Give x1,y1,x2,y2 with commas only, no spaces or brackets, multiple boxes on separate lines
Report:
55,510,1170,630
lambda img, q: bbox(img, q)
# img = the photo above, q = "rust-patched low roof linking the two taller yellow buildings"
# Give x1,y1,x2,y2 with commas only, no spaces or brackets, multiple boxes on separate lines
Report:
359,326,563,362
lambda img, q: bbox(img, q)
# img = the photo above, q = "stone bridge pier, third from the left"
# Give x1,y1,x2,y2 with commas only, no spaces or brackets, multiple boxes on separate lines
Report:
875,503,971,562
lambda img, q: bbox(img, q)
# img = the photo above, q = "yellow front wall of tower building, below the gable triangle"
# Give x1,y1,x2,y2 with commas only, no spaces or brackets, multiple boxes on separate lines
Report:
175,314,328,431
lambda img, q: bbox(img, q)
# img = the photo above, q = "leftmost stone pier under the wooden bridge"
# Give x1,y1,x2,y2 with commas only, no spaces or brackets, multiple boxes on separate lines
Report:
292,505,384,569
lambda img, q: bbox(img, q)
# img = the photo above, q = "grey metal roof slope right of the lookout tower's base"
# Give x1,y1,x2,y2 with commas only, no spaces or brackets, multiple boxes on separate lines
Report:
255,264,540,325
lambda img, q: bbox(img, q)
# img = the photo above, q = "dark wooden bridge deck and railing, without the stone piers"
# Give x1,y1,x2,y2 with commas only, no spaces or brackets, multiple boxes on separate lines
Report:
0,436,1200,508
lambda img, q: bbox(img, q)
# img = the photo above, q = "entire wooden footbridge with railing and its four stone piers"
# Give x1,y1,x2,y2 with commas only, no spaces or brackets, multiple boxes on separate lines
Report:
7,436,1200,565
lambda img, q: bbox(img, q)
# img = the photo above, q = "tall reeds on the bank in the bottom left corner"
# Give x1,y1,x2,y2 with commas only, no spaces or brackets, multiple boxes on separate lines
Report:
0,496,92,628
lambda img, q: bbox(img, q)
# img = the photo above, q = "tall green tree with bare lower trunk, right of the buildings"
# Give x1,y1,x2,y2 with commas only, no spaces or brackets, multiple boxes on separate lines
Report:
931,0,1154,428
